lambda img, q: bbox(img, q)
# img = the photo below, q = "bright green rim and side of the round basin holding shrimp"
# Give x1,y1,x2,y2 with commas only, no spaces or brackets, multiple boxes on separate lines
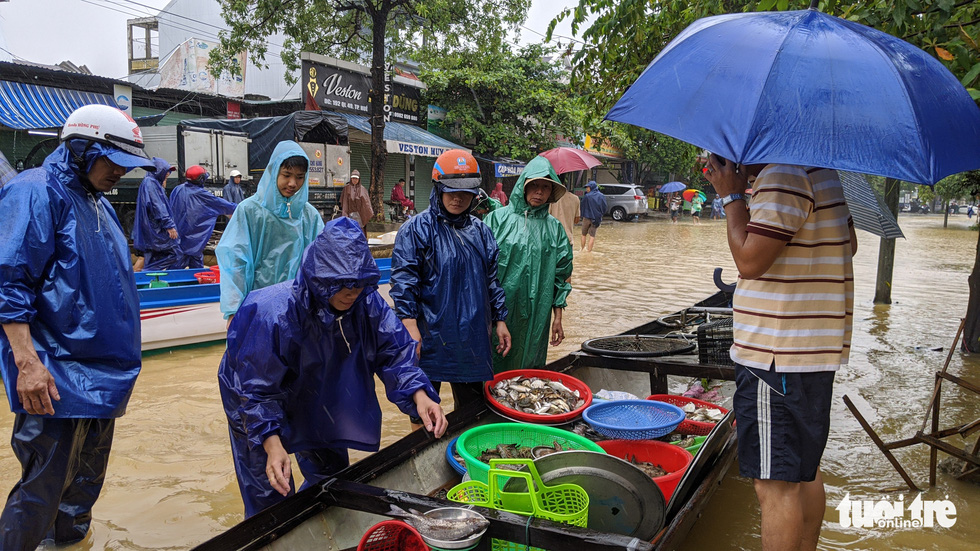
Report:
456,423,606,484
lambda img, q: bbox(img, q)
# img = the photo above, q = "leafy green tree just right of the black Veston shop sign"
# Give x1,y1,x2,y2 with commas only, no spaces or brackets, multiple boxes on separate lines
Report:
420,45,583,160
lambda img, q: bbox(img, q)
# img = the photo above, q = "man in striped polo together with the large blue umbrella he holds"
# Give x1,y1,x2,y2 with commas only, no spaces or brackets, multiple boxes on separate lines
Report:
606,1,980,550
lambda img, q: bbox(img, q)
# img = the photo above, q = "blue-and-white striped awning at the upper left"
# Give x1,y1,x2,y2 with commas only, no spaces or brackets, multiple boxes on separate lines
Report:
0,80,116,130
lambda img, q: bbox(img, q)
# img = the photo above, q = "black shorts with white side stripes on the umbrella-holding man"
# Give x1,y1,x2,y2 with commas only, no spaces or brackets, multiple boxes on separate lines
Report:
732,364,834,482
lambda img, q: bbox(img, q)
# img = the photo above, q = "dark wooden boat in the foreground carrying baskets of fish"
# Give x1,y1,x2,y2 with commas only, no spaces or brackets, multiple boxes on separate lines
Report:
195,292,736,551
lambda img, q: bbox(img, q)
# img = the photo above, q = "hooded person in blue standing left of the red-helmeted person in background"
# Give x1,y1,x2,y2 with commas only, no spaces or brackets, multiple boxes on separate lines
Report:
133,157,180,272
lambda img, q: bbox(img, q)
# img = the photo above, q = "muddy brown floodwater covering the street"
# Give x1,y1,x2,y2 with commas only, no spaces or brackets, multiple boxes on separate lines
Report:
0,215,980,551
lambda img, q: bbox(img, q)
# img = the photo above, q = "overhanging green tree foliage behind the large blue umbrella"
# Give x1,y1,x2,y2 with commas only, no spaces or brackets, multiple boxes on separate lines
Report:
548,0,980,188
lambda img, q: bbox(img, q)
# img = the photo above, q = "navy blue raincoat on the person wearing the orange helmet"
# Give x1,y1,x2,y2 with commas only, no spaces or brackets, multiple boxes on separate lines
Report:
390,186,507,383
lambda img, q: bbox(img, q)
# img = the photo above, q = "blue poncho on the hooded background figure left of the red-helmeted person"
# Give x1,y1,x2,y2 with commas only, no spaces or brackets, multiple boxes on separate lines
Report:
133,157,180,251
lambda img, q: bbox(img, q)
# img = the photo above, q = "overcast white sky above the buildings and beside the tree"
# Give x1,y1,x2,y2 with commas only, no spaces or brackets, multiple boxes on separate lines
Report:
0,0,578,78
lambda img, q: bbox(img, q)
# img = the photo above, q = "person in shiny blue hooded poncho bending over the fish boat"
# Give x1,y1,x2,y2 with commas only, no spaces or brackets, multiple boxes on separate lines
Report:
218,218,447,516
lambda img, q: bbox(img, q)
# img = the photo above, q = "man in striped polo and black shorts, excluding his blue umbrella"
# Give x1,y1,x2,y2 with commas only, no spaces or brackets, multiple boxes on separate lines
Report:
705,155,857,550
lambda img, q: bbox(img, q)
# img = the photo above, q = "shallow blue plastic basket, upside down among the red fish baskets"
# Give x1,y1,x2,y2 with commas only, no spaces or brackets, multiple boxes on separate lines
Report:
582,400,685,440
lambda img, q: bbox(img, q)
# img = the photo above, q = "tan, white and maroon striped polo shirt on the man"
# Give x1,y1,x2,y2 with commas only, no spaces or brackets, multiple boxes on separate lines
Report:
730,164,854,372
